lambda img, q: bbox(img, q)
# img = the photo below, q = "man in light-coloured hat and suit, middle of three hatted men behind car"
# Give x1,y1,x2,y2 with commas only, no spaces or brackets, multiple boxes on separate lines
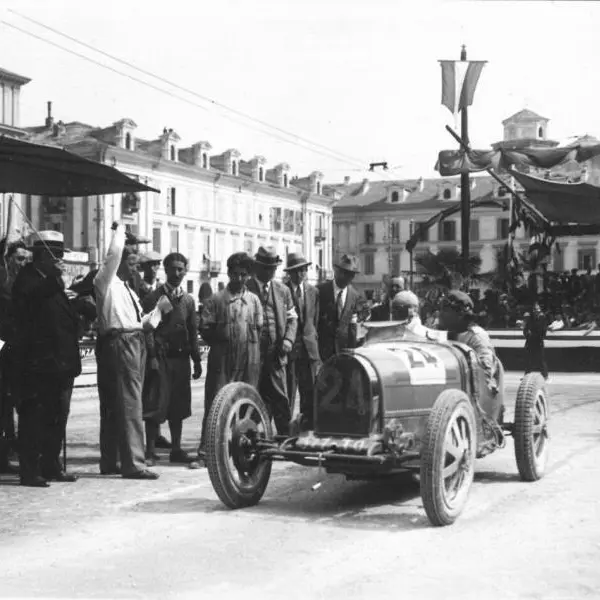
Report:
285,252,321,429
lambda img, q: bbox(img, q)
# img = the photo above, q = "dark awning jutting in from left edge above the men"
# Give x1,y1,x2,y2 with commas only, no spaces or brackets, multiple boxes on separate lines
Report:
0,136,159,197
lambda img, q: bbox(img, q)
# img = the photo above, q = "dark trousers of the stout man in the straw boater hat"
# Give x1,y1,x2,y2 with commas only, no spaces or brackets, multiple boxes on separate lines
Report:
19,373,74,479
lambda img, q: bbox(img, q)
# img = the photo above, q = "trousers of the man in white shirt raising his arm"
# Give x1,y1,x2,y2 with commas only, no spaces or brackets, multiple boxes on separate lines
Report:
96,331,146,475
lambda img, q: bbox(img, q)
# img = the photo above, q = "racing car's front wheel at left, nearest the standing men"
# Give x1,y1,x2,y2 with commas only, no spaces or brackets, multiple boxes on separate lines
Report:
205,382,273,509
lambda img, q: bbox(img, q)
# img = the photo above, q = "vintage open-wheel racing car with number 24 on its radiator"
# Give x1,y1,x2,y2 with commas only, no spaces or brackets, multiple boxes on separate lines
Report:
206,323,549,525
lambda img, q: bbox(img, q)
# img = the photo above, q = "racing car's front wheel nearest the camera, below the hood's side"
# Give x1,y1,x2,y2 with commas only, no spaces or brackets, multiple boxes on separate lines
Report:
420,390,477,526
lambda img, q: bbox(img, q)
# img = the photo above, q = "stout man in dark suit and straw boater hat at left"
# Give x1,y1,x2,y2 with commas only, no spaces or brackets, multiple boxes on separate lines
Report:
13,231,81,487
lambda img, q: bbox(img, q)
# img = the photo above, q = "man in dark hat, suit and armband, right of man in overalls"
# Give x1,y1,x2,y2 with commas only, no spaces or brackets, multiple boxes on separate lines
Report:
247,246,298,435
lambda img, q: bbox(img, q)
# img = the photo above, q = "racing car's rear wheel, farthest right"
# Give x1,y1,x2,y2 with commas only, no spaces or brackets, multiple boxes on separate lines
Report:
513,373,550,481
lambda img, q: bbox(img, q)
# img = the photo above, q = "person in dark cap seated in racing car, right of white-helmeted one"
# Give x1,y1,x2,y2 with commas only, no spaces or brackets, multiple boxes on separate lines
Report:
440,290,499,394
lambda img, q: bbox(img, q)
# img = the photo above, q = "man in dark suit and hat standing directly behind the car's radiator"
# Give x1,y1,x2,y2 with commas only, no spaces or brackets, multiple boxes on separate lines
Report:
317,254,361,362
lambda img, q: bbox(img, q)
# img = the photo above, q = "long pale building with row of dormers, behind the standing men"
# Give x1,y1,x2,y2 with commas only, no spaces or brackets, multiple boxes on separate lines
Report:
18,103,334,293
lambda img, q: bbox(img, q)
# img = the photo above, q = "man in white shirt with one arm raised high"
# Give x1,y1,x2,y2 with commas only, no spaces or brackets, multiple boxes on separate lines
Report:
94,223,164,479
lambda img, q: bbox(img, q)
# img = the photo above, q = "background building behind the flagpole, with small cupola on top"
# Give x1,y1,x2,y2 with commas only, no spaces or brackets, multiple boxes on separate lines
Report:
331,110,600,294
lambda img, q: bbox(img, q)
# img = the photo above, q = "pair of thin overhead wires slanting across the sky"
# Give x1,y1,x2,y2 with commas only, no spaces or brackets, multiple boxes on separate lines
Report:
0,9,386,170
